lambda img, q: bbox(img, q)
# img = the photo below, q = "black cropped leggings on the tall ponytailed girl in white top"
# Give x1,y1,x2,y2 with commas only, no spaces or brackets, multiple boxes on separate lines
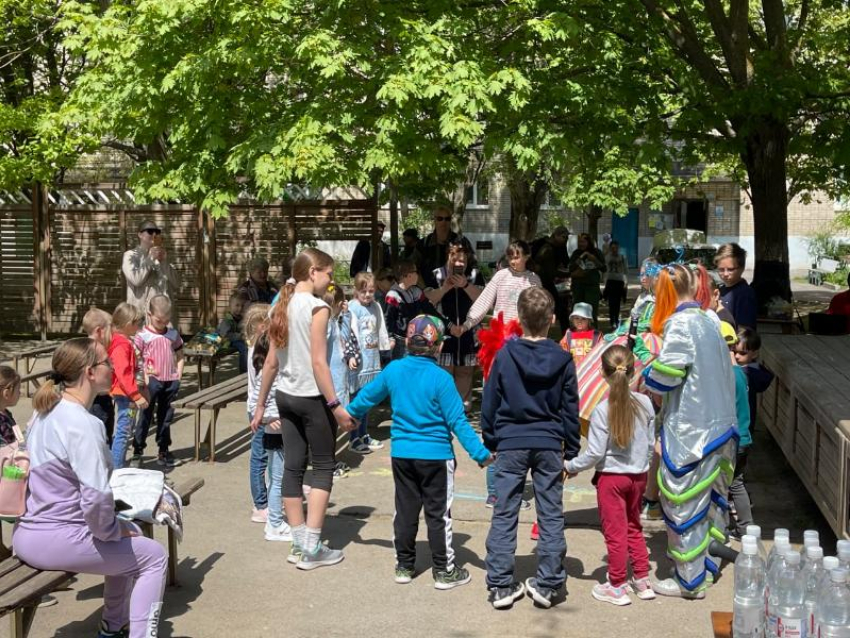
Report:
275,390,337,498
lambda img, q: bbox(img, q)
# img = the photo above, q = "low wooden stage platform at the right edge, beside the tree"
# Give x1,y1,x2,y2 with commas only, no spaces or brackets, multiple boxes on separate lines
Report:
759,335,850,538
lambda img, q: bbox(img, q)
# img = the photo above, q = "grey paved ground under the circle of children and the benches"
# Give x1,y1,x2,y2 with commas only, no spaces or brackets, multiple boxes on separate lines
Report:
0,286,835,638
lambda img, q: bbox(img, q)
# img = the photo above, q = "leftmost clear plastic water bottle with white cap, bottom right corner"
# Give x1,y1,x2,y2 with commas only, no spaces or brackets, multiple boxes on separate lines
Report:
732,535,765,638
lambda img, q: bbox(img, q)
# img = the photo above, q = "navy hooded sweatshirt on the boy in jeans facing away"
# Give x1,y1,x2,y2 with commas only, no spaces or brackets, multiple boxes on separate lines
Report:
481,339,581,460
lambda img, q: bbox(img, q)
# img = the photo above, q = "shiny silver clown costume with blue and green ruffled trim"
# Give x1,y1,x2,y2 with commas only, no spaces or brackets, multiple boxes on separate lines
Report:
644,302,738,592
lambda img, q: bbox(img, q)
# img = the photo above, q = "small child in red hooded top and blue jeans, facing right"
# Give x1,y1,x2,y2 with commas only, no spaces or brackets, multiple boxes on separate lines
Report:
107,303,148,470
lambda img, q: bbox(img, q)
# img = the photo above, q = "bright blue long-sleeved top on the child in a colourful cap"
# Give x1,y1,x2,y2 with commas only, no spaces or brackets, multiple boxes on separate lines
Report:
346,354,490,464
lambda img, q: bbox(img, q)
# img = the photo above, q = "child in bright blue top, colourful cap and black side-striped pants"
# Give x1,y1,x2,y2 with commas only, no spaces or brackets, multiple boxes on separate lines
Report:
348,315,492,589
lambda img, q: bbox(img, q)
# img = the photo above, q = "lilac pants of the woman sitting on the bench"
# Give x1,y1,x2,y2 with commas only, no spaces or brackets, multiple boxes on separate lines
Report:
12,526,168,638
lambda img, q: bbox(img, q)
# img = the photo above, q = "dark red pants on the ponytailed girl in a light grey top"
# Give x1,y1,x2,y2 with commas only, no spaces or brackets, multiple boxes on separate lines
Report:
594,473,649,587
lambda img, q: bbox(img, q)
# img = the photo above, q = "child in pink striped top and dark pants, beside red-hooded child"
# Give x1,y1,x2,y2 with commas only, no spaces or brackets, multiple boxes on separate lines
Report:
130,295,184,467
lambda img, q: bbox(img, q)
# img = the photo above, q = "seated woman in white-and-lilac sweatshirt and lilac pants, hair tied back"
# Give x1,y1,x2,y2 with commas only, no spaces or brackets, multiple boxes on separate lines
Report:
12,338,167,638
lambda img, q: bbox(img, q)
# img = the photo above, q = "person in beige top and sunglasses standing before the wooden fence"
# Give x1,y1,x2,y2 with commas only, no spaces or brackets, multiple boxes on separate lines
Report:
121,220,180,313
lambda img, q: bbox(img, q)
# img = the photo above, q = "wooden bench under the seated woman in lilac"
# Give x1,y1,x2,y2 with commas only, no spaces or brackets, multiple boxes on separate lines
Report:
0,479,204,638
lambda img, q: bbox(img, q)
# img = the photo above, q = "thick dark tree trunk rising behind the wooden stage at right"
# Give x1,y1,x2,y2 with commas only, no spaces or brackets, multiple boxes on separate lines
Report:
736,118,791,313
